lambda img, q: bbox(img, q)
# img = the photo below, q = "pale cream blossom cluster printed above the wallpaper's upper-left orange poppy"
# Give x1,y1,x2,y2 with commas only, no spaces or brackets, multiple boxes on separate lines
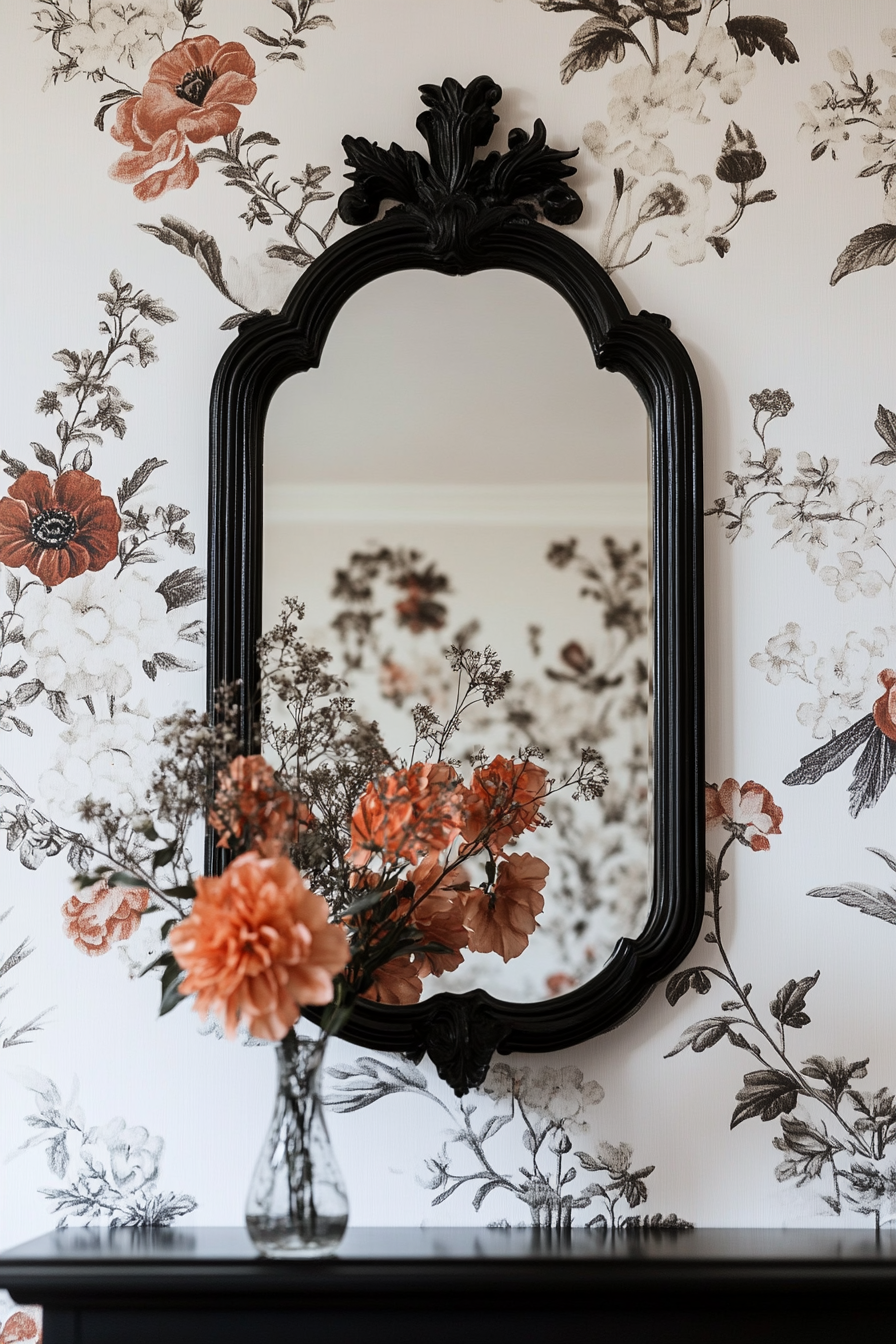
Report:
64,0,181,75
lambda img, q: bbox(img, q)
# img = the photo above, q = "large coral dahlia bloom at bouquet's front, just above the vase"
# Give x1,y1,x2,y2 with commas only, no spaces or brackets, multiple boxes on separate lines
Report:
168,851,348,1040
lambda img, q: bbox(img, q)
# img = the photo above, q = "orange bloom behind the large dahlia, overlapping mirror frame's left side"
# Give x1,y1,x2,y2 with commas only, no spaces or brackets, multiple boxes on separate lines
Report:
208,755,313,857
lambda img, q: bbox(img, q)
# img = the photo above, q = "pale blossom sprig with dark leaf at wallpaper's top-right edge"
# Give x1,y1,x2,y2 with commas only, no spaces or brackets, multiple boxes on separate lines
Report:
799,28,896,285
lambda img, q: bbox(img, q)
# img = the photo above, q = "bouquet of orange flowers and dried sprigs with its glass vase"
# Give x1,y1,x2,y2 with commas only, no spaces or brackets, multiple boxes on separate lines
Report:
64,599,607,1255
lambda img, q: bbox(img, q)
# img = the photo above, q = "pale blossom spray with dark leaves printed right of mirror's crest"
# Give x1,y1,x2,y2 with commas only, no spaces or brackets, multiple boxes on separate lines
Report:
535,0,799,271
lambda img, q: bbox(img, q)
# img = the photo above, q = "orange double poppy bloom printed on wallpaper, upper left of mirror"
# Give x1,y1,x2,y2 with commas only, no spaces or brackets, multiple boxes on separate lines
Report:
109,36,255,200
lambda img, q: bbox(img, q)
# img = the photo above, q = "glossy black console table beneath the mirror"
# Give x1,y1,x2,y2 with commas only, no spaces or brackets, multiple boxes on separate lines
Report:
0,1228,896,1344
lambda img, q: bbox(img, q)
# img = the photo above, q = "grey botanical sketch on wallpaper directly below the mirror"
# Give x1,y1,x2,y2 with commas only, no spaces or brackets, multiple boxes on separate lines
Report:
325,1055,692,1231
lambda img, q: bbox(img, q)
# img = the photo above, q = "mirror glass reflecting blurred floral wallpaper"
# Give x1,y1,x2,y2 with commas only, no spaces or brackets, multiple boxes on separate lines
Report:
263,270,653,1003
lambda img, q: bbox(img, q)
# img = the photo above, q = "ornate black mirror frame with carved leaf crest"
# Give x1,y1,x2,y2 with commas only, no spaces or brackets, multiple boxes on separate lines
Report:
207,75,704,1094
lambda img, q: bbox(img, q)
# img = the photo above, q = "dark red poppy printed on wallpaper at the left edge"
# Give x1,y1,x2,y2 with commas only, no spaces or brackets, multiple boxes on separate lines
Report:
0,472,121,587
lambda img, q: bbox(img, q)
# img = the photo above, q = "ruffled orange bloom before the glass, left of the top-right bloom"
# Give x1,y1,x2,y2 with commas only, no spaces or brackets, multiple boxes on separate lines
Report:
347,762,463,868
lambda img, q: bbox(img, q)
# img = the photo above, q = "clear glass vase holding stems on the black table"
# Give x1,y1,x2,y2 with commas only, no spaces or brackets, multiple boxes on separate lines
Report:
246,1031,348,1259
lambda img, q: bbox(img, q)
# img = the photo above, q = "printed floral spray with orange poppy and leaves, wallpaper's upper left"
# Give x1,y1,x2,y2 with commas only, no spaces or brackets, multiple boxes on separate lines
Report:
34,0,337,331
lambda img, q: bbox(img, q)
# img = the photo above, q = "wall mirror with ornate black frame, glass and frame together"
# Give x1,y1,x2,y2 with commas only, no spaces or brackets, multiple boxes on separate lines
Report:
207,75,704,1095
